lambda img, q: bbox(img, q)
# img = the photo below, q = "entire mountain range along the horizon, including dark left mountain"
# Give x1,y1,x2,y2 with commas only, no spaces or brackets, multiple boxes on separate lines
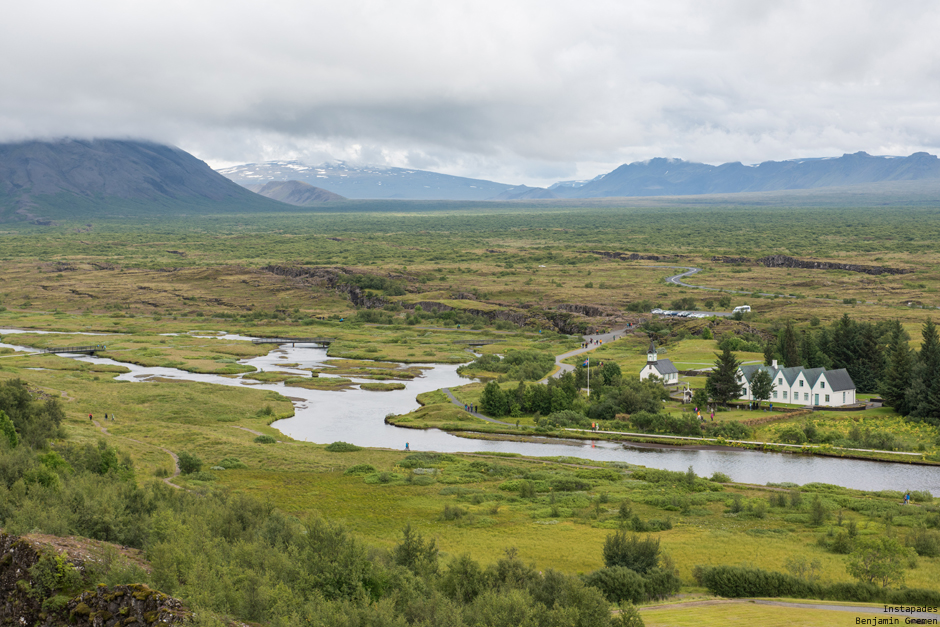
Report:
0,139,940,224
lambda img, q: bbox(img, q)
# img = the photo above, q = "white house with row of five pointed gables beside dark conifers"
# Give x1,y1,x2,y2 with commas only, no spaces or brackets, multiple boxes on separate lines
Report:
738,361,856,407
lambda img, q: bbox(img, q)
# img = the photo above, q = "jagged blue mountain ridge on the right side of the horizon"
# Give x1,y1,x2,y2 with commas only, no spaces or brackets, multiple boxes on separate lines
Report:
549,152,940,198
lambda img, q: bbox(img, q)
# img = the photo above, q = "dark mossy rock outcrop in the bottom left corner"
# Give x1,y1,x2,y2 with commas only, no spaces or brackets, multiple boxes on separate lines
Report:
0,533,192,627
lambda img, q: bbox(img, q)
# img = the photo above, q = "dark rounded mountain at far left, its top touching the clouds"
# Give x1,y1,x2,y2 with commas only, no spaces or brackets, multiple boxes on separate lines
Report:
0,139,291,224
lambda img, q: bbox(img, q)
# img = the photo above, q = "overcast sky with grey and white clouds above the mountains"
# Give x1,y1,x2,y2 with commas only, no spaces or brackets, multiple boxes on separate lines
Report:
0,0,940,185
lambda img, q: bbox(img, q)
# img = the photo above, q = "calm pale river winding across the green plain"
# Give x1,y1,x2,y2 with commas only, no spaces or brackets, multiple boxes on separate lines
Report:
0,330,940,494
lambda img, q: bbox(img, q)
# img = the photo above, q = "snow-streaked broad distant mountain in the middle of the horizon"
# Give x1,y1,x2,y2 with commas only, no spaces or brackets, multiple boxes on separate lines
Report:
219,161,514,200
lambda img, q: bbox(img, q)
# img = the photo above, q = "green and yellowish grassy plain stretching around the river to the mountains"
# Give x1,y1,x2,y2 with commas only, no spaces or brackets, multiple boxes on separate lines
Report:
0,206,940,612
